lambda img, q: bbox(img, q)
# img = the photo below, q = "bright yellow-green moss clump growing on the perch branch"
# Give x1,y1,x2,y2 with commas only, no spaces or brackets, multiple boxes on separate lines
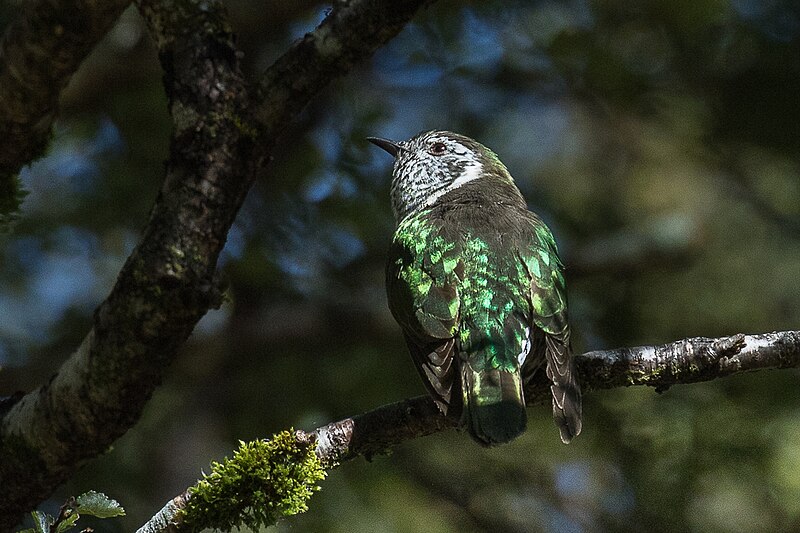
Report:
180,430,326,531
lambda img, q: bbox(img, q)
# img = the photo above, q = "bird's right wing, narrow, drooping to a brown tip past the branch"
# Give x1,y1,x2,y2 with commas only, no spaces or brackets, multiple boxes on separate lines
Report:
521,216,581,442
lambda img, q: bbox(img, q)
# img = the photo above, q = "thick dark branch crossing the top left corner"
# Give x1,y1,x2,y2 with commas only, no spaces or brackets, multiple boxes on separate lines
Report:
0,0,131,216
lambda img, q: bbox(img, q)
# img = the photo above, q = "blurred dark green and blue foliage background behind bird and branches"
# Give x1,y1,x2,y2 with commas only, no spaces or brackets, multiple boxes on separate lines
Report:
0,0,800,532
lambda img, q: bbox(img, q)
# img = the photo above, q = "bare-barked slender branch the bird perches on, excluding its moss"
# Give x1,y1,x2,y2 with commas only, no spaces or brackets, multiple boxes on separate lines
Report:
137,331,800,533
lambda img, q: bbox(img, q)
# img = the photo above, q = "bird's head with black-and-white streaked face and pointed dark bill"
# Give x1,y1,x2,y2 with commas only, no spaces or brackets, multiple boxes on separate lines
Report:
367,131,512,223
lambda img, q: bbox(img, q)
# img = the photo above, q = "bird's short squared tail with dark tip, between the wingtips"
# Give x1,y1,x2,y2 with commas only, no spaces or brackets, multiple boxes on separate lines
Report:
461,361,528,446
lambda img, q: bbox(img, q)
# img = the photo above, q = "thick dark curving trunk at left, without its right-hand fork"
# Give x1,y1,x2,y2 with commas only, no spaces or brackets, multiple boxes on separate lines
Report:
0,1,247,530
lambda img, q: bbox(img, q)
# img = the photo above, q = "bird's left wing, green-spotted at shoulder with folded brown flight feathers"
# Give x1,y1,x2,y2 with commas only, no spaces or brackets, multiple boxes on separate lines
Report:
386,218,464,415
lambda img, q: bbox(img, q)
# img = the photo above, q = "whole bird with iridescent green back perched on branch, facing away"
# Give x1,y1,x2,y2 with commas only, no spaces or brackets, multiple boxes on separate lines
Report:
367,130,582,447
